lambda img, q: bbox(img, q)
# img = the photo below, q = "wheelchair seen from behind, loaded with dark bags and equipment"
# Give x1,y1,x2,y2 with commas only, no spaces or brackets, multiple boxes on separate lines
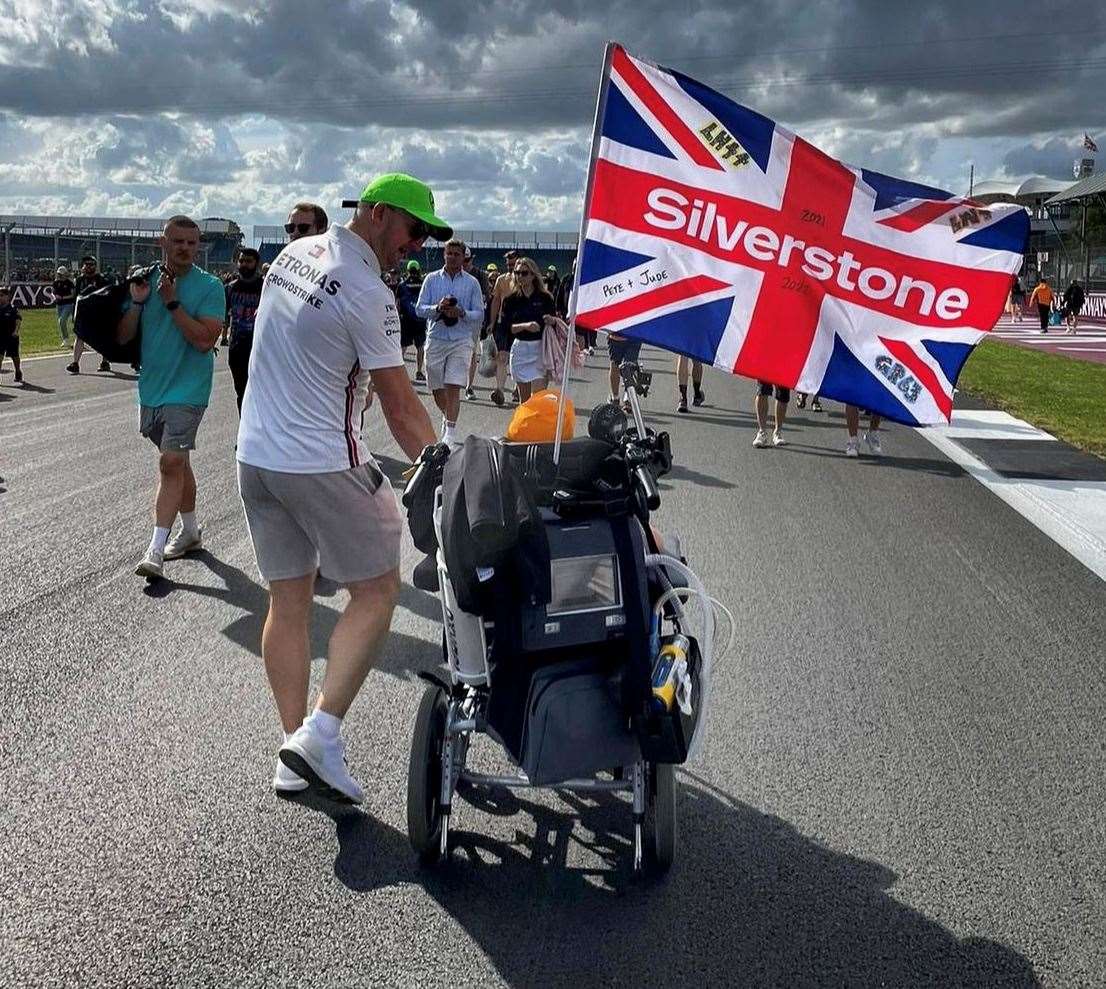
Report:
404,365,732,874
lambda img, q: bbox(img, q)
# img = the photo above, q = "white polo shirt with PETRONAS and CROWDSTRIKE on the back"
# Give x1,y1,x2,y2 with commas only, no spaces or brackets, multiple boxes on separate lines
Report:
238,223,404,473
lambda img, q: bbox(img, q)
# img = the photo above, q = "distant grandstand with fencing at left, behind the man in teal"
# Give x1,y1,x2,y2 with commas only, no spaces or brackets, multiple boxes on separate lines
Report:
0,216,242,283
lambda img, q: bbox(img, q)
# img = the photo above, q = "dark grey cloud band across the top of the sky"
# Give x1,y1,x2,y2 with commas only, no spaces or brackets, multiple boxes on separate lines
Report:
0,0,1106,142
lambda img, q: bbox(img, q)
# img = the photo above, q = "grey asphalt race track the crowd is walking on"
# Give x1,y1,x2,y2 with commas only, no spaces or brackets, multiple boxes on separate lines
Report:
0,352,1106,987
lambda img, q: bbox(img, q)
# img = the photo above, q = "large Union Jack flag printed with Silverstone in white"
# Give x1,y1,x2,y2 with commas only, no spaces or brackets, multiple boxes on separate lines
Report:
575,44,1030,426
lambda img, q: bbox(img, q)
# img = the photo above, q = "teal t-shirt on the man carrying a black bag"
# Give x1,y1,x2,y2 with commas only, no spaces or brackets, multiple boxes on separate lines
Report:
138,264,227,406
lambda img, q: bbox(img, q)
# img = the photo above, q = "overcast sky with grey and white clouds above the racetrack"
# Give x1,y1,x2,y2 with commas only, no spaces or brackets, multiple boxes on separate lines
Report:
0,0,1106,236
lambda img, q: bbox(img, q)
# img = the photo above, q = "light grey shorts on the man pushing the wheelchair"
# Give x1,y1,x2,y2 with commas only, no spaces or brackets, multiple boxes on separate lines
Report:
238,461,403,584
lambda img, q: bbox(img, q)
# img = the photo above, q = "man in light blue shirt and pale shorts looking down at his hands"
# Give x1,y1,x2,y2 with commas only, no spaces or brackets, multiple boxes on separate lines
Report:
415,240,483,444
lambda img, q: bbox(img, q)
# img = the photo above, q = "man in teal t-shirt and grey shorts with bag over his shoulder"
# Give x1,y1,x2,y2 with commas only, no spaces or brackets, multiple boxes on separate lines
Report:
118,216,226,579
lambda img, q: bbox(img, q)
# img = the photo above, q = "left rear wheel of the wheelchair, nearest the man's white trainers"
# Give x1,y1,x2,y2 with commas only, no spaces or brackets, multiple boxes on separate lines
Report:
407,686,449,865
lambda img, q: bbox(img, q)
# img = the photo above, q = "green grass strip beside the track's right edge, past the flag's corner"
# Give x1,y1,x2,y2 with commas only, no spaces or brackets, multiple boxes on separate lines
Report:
957,337,1106,457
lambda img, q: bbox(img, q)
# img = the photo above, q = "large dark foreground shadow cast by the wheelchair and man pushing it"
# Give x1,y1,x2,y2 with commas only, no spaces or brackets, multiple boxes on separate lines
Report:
316,772,1040,989
